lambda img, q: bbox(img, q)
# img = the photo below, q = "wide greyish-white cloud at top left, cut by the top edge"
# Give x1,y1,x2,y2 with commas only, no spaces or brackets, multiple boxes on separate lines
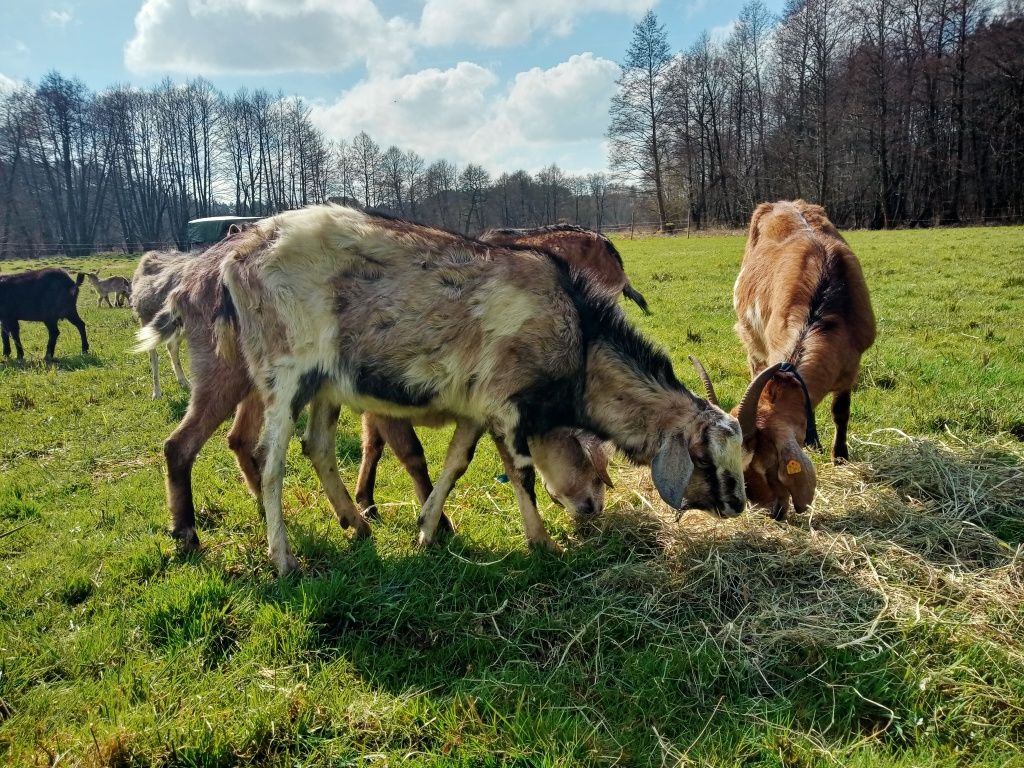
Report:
125,0,413,75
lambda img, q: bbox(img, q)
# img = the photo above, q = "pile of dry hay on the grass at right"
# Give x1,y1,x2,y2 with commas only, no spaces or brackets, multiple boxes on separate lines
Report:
577,430,1024,743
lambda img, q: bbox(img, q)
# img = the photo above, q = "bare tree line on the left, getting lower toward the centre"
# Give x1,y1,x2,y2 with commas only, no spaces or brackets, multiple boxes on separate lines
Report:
0,73,636,258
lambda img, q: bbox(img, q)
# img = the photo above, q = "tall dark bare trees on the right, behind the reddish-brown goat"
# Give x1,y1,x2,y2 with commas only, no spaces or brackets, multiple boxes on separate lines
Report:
608,0,1024,228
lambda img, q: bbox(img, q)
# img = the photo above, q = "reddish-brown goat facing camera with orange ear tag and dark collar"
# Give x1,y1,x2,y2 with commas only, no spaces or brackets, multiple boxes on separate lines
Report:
698,200,876,519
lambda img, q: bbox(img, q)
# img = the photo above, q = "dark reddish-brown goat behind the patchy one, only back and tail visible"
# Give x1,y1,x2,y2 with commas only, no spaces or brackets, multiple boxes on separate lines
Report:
480,224,650,314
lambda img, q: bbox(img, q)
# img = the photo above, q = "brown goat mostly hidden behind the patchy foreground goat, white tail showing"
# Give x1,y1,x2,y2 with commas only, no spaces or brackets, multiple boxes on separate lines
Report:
137,239,607,551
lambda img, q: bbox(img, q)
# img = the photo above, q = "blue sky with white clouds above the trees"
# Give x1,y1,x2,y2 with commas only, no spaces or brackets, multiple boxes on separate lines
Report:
0,0,782,173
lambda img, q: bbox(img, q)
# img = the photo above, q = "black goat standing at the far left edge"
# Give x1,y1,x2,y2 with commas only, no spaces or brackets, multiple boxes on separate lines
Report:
0,268,89,360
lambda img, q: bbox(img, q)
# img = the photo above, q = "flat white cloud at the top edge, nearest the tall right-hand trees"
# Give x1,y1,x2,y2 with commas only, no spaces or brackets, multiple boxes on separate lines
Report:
418,0,656,48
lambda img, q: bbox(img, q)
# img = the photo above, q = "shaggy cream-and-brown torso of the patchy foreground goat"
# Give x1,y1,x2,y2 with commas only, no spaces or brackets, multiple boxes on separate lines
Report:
224,206,582,417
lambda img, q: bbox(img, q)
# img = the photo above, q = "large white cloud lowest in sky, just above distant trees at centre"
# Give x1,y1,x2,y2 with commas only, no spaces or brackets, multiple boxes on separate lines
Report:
312,53,618,172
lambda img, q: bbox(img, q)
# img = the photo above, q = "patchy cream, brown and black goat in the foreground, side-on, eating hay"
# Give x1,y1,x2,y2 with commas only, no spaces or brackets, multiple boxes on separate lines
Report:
218,206,745,573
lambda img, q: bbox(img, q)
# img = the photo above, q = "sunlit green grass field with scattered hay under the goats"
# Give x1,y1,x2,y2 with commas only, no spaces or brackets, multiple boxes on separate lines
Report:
0,227,1024,768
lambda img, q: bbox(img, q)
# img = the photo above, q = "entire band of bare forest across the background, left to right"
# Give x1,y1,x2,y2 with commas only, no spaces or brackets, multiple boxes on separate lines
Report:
0,0,1024,258
